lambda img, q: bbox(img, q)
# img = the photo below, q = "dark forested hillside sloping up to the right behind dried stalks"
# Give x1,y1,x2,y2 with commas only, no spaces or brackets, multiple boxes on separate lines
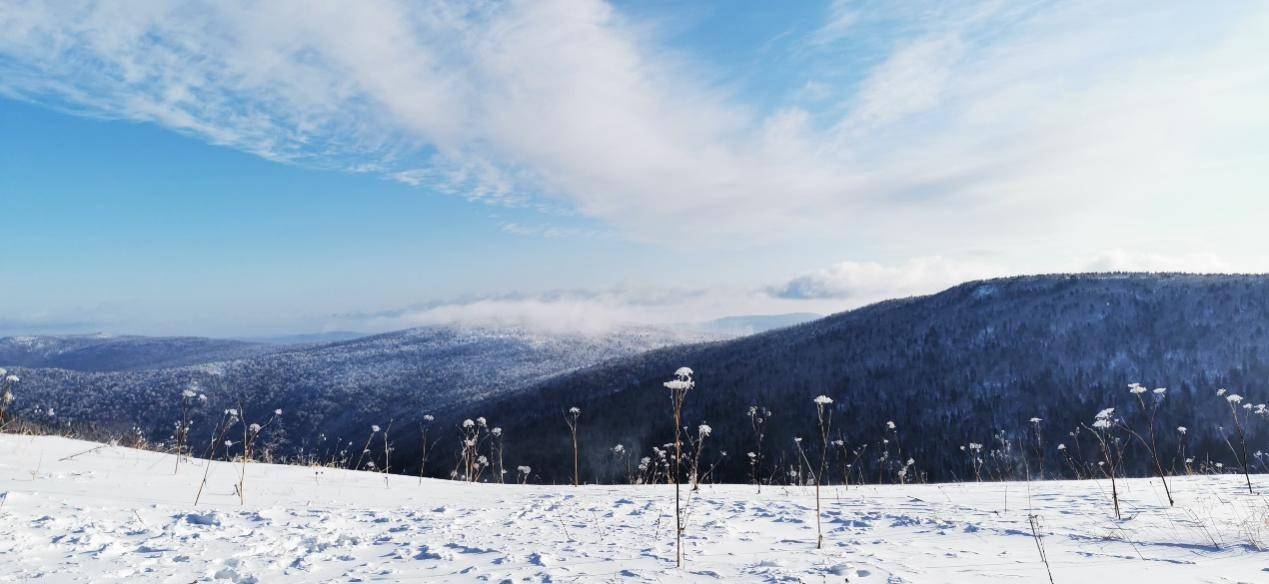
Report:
431,274,1269,481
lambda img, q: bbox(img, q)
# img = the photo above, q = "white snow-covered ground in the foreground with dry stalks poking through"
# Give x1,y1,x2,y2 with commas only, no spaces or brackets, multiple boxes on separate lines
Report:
0,435,1269,583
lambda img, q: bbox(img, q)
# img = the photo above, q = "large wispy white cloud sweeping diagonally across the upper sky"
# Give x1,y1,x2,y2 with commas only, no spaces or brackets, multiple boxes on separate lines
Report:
0,0,1269,255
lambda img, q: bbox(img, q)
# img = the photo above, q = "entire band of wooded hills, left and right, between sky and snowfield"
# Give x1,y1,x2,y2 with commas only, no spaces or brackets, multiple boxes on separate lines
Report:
0,274,1269,481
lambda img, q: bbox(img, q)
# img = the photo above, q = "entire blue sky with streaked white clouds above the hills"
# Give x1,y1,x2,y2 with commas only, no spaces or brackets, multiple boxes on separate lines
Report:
0,0,1269,335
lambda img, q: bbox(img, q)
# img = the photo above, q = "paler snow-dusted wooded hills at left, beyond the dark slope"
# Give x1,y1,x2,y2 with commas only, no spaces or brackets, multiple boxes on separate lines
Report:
0,326,718,452
